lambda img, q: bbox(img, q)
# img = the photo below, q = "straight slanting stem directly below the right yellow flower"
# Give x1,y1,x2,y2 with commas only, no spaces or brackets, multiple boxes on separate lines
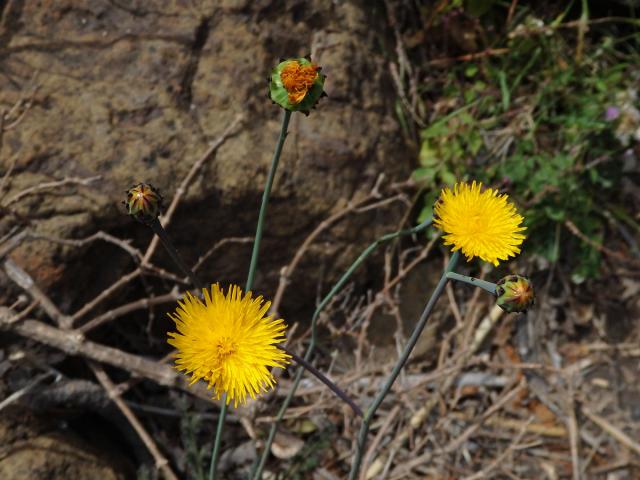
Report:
349,252,460,480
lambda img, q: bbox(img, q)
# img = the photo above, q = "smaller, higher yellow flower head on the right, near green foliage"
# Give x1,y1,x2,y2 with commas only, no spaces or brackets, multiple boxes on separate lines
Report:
433,181,526,266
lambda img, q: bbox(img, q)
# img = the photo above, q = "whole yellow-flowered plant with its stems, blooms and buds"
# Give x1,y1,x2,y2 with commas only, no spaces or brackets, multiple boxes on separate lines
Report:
125,58,533,480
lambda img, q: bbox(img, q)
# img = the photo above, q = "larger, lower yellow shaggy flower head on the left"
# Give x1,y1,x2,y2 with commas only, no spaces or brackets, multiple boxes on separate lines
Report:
167,283,289,407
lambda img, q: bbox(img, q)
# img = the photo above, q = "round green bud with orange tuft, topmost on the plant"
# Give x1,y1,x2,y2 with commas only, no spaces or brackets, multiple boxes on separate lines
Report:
269,58,326,115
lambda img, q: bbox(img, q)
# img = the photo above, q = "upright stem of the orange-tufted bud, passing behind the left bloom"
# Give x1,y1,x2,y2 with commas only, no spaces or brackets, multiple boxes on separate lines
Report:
209,110,291,480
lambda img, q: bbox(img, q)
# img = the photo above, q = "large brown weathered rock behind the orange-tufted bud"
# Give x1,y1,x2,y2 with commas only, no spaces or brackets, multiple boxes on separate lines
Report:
0,0,413,308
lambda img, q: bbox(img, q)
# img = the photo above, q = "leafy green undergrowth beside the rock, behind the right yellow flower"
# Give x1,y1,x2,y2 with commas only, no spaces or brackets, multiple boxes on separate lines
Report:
414,5,640,282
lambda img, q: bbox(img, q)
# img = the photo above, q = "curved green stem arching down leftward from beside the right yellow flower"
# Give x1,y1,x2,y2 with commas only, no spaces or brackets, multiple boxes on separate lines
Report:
250,218,433,480
